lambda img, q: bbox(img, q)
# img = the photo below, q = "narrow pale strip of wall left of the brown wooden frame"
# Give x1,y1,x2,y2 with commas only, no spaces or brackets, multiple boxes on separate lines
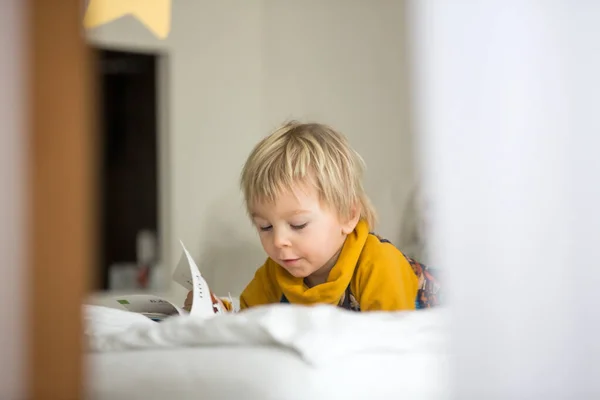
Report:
0,0,27,400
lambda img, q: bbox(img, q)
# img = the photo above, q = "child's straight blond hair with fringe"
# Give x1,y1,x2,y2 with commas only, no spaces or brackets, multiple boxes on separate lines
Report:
241,121,376,228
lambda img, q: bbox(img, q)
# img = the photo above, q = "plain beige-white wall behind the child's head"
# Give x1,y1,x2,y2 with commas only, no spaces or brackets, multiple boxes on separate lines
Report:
89,0,413,295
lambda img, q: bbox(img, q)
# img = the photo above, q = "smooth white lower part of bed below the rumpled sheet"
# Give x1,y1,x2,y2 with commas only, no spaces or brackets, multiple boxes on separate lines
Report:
86,346,450,400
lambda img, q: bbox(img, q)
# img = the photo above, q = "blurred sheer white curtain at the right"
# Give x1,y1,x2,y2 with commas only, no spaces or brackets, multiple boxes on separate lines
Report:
407,0,600,400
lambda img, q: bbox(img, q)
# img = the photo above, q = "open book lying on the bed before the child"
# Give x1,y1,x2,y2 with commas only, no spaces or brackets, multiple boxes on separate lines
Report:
115,241,226,322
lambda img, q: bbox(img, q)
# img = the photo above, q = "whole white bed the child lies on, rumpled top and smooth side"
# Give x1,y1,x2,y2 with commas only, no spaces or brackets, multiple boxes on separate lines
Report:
86,305,449,400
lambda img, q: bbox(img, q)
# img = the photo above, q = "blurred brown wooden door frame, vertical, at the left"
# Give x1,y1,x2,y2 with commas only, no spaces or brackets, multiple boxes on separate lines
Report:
28,0,96,400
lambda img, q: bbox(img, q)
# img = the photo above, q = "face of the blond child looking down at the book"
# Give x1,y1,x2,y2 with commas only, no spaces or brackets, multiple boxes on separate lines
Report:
252,186,358,281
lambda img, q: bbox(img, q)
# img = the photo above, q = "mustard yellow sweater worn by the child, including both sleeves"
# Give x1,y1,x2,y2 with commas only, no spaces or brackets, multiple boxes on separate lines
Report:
228,221,418,311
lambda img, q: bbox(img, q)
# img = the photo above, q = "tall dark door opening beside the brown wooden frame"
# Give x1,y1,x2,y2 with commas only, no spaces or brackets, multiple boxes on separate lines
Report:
96,49,159,290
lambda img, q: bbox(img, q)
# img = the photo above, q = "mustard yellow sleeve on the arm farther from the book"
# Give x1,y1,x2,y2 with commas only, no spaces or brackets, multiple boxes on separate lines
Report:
353,244,418,311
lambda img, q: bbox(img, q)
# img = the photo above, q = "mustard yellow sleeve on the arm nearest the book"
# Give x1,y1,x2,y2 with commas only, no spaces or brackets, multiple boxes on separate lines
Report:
240,260,281,310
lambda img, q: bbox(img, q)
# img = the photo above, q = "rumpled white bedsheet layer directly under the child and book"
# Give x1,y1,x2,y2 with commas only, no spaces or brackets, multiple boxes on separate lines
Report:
87,304,446,365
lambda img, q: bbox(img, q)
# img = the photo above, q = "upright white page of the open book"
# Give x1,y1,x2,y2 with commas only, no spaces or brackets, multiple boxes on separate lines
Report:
173,241,215,317
